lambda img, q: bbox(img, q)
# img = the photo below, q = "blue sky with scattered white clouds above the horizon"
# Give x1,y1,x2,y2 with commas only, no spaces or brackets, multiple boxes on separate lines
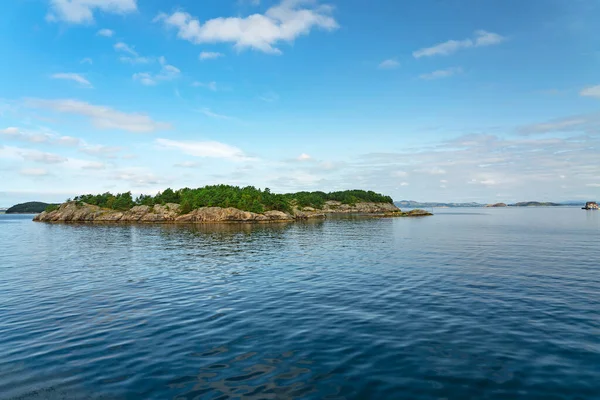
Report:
0,0,600,206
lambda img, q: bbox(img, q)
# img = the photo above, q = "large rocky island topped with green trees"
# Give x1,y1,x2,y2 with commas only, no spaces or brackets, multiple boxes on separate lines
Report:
34,185,432,223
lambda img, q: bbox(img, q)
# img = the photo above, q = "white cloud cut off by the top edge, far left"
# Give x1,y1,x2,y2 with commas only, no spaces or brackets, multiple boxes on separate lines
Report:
46,0,137,24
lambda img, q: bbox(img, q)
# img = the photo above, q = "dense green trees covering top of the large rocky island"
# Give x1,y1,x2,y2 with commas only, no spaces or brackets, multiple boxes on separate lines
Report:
46,185,393,214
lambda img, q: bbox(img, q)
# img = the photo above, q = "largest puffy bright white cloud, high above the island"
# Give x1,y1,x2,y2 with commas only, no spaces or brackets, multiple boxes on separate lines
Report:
154,0,339,54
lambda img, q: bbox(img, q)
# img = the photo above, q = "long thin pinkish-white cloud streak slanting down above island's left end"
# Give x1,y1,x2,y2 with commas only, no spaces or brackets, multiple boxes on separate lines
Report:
26,99,171,132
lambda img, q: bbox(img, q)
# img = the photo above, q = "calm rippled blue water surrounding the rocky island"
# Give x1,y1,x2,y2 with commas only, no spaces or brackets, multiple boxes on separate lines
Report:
0,208,600,400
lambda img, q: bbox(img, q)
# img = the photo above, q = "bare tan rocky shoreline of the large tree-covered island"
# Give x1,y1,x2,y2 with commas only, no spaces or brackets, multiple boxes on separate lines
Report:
33,201,432,224
